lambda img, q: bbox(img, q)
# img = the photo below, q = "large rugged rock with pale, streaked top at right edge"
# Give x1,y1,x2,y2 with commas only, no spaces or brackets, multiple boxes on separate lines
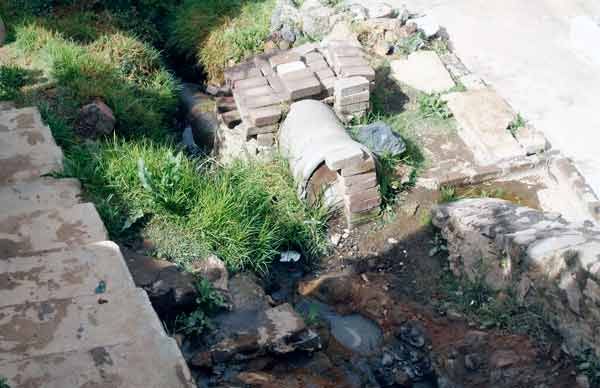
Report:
433,198,600,354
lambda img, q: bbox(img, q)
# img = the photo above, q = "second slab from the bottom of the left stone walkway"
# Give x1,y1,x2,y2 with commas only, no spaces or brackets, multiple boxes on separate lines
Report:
0,288,164,364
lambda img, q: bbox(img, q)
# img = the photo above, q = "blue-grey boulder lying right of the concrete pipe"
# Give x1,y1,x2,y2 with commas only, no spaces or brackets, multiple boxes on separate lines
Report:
355,121,406,156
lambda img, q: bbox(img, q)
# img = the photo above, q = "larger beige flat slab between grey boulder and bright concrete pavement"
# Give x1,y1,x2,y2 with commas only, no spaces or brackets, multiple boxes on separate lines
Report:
445,90,525,165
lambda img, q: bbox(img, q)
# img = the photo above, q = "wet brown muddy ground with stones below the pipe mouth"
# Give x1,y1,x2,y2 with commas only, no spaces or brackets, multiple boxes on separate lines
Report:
229,182,576,388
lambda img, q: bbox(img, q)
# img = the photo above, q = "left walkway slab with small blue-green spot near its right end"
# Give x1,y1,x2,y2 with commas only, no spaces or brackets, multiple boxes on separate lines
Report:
0,241,135,307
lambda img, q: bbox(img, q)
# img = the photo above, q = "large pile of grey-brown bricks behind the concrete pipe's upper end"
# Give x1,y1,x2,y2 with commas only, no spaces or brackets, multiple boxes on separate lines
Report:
217,41,375,158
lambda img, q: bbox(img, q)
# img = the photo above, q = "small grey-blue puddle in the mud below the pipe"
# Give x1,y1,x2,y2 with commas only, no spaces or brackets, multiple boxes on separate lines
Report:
296,299,383,355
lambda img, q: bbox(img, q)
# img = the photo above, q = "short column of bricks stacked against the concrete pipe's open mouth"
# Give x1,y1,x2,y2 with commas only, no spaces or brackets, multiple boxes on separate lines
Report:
325,142,381,227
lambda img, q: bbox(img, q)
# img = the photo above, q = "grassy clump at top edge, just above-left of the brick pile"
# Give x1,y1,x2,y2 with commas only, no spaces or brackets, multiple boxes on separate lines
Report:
168,0,275,82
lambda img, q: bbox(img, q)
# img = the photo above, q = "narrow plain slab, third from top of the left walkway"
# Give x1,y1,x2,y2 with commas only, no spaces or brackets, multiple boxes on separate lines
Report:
0,178,81,215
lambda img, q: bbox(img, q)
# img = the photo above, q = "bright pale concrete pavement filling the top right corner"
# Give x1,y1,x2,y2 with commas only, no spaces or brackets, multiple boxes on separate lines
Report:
352,0,600,194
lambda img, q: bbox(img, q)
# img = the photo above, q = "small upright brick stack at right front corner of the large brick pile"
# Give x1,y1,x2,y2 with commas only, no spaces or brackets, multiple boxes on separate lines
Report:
333,76,370,120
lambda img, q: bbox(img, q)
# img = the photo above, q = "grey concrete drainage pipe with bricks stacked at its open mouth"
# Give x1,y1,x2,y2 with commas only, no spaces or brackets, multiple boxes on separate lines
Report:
279,100,381,226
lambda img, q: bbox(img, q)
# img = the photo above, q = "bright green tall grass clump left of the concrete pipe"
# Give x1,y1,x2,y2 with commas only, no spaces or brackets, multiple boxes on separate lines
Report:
68,139,328,272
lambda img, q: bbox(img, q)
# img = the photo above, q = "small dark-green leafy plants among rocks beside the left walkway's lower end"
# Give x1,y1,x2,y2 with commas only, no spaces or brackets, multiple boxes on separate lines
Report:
174,279,226,336
